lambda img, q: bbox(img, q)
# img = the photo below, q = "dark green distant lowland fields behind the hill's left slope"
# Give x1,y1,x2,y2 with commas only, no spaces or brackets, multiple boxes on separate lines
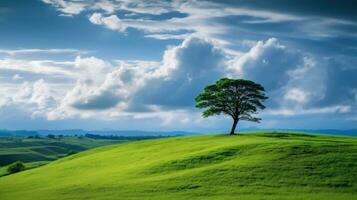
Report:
0,136,156,176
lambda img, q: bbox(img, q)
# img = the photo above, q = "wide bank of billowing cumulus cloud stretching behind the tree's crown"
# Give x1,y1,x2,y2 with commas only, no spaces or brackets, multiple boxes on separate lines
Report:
0,37,357,129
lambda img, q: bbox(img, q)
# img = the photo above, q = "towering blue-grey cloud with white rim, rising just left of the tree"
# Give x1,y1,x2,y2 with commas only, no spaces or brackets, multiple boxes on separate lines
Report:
130,38,226,110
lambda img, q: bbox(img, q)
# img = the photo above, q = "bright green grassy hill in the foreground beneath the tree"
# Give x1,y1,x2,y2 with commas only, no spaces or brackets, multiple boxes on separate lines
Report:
0,133,357,200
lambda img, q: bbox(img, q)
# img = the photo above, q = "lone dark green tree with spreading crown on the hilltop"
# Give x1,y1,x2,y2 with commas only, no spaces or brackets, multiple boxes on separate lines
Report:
195,78,268,135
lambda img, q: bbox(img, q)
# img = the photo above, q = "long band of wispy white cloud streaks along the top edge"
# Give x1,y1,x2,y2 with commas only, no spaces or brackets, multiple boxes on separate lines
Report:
43,0,355,45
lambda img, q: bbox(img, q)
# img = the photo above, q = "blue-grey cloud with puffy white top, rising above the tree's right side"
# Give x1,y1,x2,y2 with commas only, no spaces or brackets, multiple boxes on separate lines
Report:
228,38,294,107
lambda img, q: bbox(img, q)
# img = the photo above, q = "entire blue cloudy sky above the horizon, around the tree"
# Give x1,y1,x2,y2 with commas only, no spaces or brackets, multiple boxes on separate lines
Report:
0,0,357,132
